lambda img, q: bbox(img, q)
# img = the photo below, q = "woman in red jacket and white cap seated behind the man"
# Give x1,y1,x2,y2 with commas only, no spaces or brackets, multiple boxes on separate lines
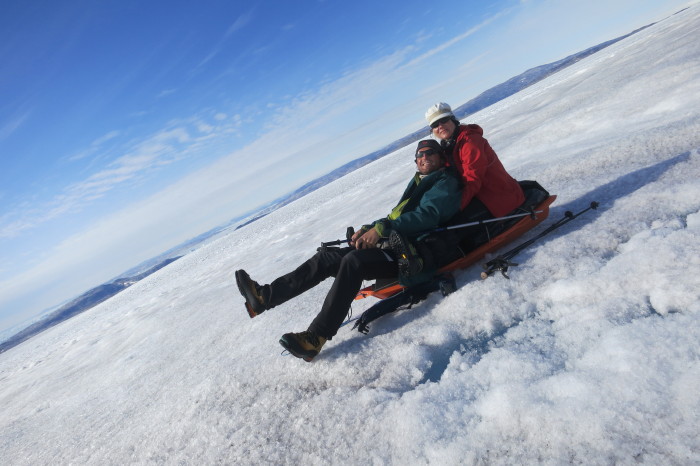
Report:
425,102,525,252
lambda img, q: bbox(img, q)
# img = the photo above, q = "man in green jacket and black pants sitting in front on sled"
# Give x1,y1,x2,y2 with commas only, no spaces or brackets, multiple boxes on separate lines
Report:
236,139,461,361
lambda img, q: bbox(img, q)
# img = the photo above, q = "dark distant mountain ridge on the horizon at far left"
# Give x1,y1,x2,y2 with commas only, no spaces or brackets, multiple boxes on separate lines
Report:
0,257,179,353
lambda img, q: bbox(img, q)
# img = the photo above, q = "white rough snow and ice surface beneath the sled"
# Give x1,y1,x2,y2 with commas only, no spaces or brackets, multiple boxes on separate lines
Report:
0,7,700,465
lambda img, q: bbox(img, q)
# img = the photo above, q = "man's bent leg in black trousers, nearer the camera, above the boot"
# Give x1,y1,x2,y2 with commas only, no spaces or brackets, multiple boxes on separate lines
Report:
309,248,399,339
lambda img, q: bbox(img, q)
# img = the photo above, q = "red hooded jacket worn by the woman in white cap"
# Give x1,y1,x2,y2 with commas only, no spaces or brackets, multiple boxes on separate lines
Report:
452,124,525,217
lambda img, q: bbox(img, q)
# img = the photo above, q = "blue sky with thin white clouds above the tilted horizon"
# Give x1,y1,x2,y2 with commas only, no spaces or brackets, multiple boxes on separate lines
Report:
0,0,692,330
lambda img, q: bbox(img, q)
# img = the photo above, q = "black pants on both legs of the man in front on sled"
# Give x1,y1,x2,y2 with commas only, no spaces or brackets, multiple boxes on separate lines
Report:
261,248,399,339
